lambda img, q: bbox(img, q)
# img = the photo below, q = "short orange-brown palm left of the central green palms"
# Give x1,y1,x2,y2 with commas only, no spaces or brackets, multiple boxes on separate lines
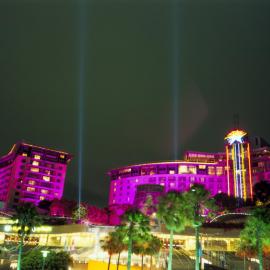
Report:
101,230,126,270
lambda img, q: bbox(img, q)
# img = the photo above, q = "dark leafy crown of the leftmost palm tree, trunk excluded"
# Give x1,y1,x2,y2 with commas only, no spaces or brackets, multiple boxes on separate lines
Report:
12,203,42,237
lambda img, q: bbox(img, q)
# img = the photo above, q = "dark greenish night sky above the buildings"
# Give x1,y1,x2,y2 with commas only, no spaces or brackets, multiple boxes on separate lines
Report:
0,0,270,206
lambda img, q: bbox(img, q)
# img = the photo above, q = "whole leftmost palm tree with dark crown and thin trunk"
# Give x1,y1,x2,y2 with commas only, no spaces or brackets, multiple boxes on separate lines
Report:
12,203,41,270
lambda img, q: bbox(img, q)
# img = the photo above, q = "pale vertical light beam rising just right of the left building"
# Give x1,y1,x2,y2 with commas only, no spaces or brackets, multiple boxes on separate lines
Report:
77,0,86,209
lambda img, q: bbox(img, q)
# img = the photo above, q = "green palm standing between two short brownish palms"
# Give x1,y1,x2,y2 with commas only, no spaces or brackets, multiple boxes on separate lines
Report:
119,209,150,270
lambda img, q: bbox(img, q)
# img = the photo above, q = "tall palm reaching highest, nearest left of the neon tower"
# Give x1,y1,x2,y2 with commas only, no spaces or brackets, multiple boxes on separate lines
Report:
184,184,216,270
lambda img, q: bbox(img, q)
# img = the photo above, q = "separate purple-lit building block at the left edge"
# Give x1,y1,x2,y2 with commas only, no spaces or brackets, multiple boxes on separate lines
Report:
0,143,71,208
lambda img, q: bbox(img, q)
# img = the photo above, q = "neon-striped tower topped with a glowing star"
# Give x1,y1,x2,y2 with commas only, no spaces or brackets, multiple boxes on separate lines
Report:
225,129,253,200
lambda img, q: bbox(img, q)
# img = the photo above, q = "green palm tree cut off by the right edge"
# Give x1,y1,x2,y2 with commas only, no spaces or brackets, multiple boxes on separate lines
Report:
240,207,270,270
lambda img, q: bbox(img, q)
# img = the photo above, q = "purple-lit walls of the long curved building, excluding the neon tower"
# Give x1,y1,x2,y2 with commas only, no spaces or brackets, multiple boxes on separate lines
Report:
109,136,270,206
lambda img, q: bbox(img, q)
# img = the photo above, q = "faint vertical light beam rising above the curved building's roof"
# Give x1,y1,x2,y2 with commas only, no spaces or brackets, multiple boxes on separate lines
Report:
171,0,180,160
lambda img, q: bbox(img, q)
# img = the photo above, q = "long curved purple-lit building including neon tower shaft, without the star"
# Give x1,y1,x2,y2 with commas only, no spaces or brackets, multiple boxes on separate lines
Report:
109,130,270,205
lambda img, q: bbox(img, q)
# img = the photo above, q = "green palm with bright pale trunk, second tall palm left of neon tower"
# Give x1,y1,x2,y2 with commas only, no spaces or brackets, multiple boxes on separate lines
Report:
157,191,187,270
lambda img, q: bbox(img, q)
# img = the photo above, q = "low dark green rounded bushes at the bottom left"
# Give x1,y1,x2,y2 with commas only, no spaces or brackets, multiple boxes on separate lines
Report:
22,250,72,270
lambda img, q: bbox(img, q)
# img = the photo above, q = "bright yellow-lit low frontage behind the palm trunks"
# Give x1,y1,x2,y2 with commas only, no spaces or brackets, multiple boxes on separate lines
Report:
0,220,270,270
